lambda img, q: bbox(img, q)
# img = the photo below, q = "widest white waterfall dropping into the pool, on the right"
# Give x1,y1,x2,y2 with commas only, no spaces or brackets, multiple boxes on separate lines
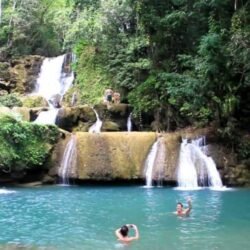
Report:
177,137,223,189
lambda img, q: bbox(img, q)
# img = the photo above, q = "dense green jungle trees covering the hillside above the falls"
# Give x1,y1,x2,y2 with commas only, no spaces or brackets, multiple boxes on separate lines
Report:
0,0,250,133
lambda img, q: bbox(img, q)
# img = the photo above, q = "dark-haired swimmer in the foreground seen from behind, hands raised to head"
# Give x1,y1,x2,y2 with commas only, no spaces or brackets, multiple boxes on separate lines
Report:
115,224,139,244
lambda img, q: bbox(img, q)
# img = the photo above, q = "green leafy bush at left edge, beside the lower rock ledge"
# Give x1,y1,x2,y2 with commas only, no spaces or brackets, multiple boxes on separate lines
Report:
0,116,59,171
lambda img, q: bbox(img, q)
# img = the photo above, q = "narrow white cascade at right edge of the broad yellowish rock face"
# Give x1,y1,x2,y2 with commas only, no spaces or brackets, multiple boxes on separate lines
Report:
144,140,158,187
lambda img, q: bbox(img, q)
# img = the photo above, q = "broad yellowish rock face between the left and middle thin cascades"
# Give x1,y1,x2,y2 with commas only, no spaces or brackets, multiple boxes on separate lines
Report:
51,132,156,181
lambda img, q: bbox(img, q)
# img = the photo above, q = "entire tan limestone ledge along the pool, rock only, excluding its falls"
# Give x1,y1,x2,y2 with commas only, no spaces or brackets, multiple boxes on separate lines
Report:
46,129,250,186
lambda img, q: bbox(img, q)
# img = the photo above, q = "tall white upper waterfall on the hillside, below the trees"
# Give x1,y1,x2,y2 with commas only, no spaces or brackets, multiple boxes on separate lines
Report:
33,55,74,124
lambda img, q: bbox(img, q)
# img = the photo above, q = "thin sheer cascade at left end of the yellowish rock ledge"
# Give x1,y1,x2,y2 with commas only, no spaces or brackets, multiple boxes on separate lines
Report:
58,135,77,185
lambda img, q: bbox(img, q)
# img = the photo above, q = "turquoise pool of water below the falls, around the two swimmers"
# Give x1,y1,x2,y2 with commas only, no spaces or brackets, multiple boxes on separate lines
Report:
0,186,250,250
